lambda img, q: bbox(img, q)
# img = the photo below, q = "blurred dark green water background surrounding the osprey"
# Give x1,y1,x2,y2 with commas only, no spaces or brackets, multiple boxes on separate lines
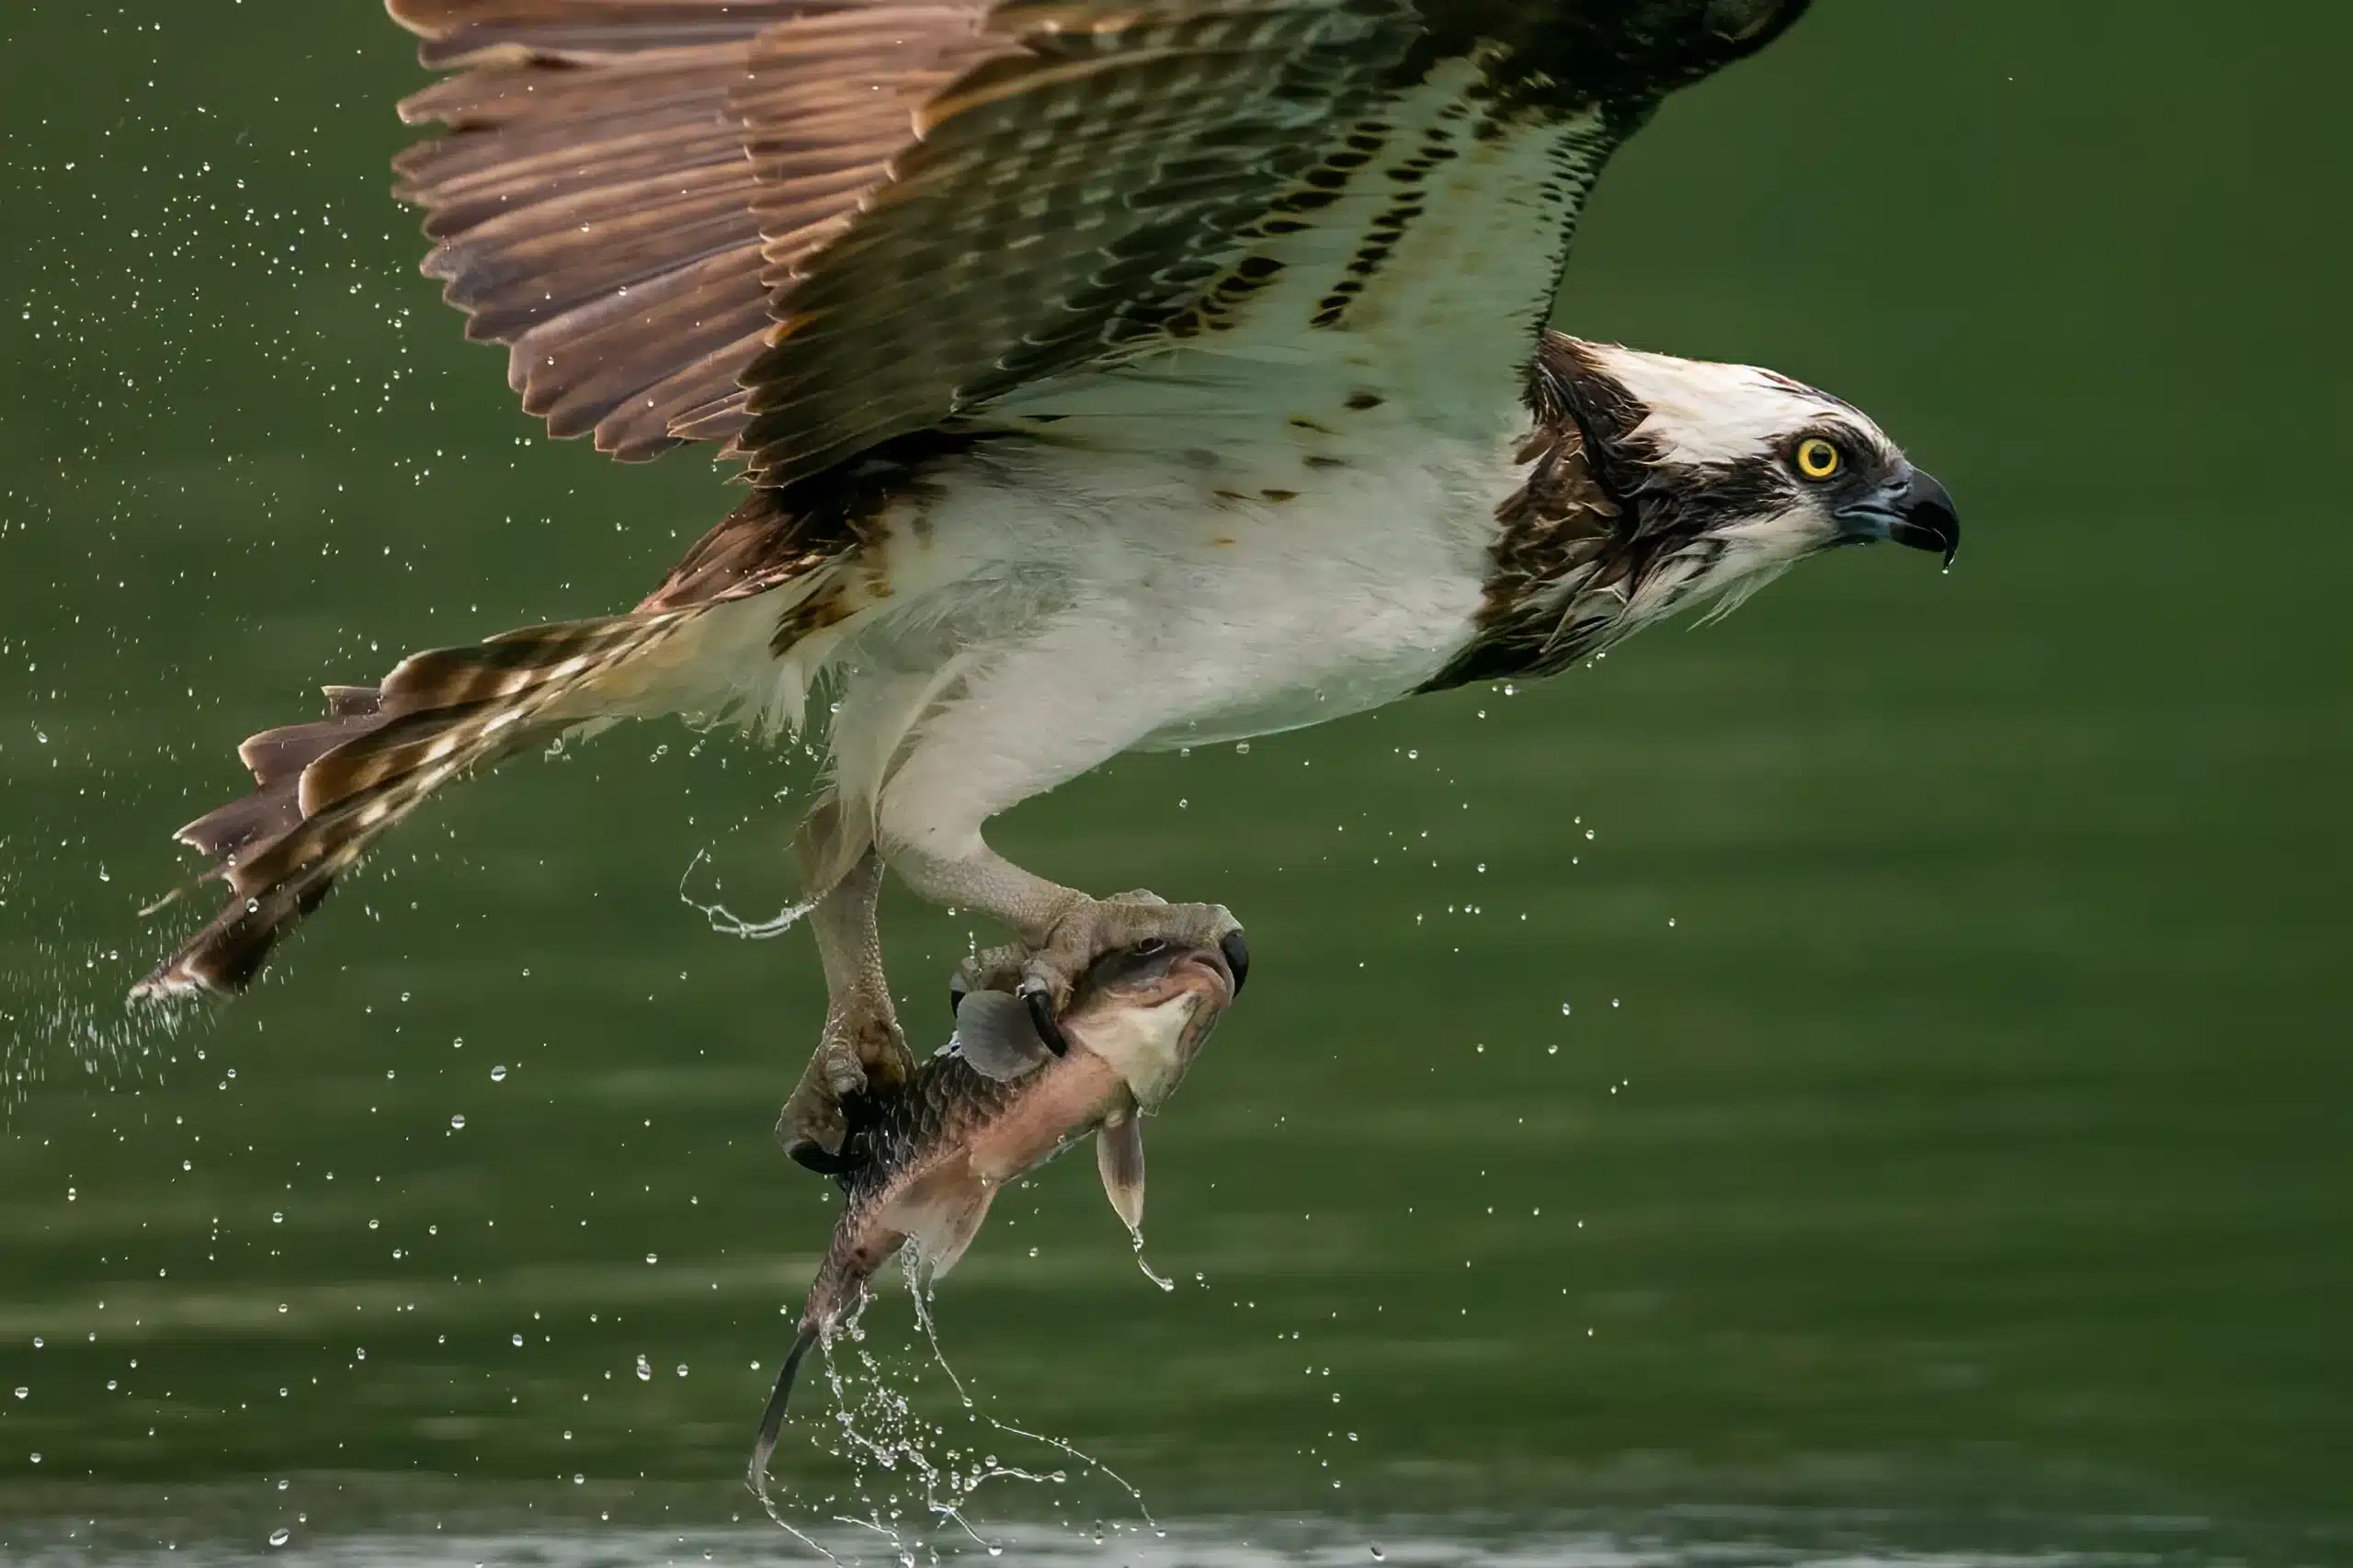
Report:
0,0,2353,1561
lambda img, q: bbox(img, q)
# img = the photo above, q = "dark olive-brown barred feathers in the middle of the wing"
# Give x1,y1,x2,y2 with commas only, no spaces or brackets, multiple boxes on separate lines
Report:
739,0,1419,485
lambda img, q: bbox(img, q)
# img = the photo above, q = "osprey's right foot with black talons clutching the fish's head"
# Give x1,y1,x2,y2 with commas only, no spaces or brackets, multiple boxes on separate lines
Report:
885,843,1249,1055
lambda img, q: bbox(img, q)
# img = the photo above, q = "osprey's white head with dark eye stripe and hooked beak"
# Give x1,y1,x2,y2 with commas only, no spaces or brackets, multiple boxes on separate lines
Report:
1539,335,1960,633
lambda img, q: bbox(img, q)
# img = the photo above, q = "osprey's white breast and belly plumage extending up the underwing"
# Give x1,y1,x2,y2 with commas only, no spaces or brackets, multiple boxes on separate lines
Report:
663,62,1593,855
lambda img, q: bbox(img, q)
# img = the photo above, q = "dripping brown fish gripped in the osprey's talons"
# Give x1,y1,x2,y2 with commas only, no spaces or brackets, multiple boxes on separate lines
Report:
748,937,1247,1495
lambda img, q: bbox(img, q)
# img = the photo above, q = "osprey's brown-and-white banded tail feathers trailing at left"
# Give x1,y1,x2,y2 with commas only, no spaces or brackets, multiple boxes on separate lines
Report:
131,605,709,996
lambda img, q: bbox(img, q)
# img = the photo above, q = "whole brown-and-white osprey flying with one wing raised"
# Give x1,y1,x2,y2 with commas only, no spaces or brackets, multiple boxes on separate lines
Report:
142,0,1960,1168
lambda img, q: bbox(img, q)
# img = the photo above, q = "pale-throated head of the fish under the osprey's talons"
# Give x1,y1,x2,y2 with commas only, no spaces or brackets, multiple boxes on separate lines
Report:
1062,937,1235,1111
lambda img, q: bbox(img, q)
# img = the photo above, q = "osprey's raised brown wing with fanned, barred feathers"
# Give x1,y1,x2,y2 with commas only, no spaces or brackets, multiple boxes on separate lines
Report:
388,0,1807,485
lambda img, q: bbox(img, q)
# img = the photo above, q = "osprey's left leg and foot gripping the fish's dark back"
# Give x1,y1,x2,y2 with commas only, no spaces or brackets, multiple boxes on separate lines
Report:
777,802,915,1175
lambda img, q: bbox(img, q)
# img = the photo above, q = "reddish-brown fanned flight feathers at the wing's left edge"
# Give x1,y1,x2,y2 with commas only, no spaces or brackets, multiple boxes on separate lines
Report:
391,0,1007,460
